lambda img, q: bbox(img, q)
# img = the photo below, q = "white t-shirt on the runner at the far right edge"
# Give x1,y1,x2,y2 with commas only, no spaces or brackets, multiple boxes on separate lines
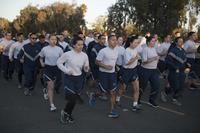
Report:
183,40,197,59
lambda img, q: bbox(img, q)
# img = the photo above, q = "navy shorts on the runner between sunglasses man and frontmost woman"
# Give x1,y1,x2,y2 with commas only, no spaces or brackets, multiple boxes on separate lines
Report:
43,65,61,81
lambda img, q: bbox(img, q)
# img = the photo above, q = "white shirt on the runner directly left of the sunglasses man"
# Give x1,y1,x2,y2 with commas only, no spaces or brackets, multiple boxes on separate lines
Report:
9,42,24,59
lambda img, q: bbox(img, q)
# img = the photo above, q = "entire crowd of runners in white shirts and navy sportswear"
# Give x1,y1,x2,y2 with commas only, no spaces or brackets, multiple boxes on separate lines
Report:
0,31,200,124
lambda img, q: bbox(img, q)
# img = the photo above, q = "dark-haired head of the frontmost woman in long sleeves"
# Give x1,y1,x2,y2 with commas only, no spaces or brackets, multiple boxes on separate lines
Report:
72,37,83,52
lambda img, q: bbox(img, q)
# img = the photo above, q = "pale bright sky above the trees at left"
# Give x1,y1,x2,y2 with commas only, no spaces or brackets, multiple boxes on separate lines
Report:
0,0,116,24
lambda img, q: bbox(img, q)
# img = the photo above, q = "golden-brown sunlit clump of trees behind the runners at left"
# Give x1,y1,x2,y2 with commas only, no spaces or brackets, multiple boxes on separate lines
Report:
9,2,87,35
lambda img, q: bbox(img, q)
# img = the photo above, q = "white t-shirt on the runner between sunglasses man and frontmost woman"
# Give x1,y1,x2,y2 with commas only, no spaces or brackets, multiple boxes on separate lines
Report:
40,45,63,66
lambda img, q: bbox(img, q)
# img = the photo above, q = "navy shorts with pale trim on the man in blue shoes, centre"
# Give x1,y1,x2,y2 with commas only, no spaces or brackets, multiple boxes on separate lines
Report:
99,71,117,92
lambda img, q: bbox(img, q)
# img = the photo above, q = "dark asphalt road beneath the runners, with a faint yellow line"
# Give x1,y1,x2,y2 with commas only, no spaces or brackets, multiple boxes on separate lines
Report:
0,74,200,133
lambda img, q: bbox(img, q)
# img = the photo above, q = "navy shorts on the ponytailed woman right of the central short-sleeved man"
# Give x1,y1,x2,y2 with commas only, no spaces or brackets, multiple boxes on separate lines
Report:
122,67,138,85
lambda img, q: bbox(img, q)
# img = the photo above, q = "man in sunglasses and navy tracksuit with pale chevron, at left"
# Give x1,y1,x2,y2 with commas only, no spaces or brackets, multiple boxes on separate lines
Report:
18,33,41,96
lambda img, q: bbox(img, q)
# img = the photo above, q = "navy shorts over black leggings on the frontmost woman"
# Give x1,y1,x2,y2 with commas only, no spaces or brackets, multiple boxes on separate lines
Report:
64,74,85,94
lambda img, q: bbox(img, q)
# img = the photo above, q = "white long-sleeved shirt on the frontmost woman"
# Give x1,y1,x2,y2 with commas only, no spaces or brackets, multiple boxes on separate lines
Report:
57,50,89,76
